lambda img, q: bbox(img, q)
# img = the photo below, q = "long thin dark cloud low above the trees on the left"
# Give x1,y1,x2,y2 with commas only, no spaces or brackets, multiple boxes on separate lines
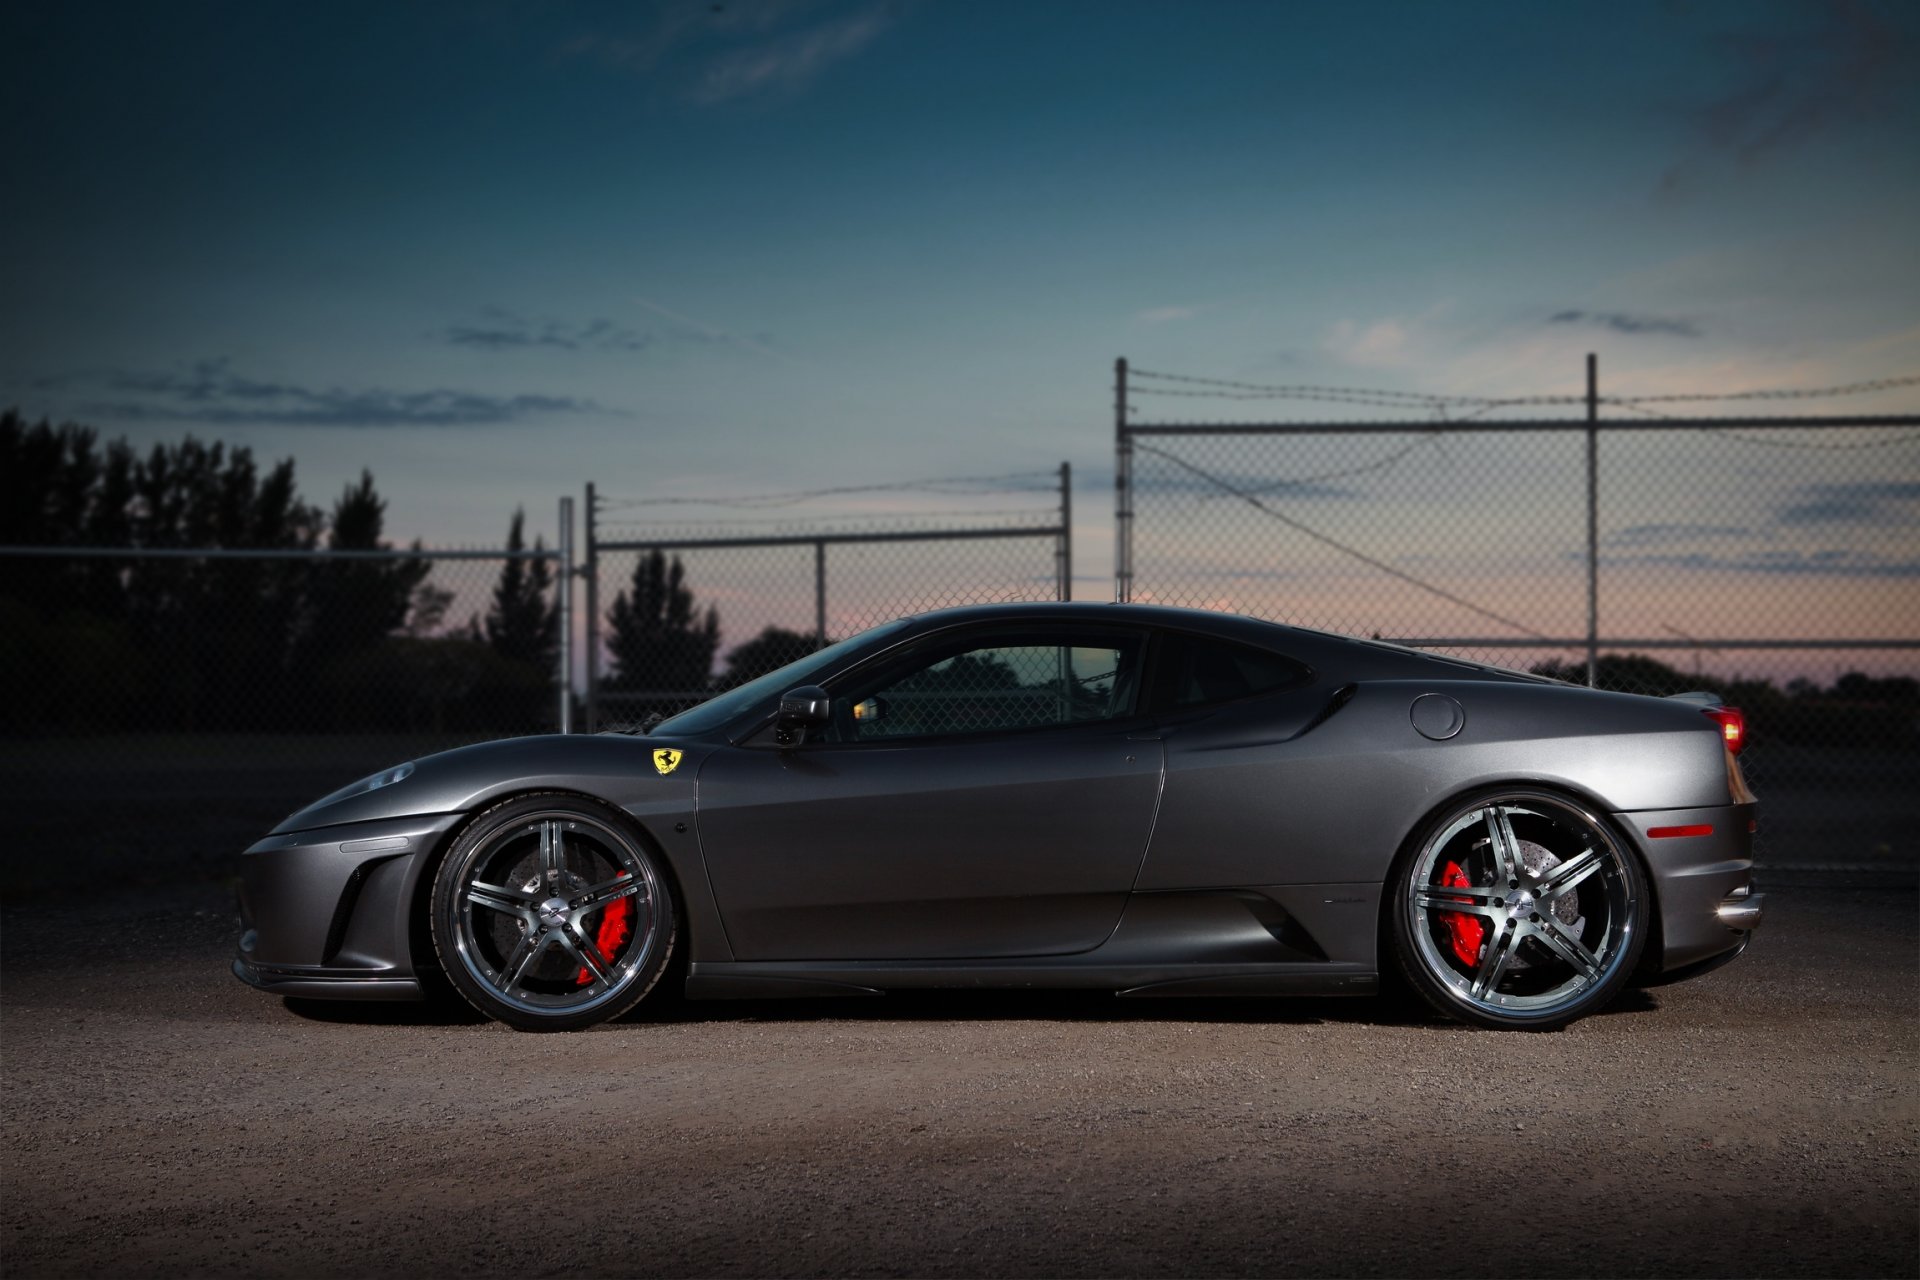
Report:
35,359,607,426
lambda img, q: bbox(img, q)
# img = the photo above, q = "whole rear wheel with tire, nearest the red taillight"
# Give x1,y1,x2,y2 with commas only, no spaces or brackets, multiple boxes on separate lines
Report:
1388,787,1651,1031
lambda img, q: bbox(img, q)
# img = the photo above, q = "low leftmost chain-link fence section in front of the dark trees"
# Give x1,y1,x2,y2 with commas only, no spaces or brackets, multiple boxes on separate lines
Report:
0,547,568,894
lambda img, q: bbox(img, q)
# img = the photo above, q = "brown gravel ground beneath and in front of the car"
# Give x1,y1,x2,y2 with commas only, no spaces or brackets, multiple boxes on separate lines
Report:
0,887,1920,1278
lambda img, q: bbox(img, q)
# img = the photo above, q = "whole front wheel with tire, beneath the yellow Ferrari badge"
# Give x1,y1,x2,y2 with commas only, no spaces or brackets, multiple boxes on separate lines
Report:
428,794,680,1031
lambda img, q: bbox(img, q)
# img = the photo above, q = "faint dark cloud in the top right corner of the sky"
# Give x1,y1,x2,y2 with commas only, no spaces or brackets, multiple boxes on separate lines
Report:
1661,0,1916,194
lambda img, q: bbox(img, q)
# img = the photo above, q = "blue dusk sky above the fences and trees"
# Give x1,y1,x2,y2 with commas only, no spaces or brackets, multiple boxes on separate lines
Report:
0,0,1920,660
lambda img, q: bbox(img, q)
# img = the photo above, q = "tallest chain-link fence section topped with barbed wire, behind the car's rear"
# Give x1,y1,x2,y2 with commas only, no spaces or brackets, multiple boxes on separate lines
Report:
1116,363,1920,873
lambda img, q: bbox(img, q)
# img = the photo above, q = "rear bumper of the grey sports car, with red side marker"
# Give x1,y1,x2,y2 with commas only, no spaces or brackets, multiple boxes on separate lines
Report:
1617,804,1766,975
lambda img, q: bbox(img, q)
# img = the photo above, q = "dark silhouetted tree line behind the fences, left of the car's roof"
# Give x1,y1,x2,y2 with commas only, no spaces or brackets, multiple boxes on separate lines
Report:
0,411,814,733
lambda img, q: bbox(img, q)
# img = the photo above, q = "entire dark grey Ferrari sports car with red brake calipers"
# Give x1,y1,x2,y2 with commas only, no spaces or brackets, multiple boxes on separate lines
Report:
232,604,1763,1031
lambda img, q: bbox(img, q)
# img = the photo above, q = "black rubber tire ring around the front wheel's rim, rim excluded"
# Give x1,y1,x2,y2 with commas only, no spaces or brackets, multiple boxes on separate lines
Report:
428,793,680,1031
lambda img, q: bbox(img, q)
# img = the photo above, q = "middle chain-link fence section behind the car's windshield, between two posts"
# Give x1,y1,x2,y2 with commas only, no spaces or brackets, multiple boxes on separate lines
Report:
584,462,1073,727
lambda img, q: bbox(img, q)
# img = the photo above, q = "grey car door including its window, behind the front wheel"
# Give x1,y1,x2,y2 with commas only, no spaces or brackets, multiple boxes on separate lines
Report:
699,624,1160,960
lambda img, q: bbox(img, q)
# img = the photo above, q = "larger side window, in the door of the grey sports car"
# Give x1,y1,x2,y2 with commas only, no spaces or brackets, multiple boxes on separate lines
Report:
835,637,1139,743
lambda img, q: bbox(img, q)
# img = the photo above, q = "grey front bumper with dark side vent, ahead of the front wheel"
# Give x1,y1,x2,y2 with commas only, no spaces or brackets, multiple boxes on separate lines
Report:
232,814,459,1000
